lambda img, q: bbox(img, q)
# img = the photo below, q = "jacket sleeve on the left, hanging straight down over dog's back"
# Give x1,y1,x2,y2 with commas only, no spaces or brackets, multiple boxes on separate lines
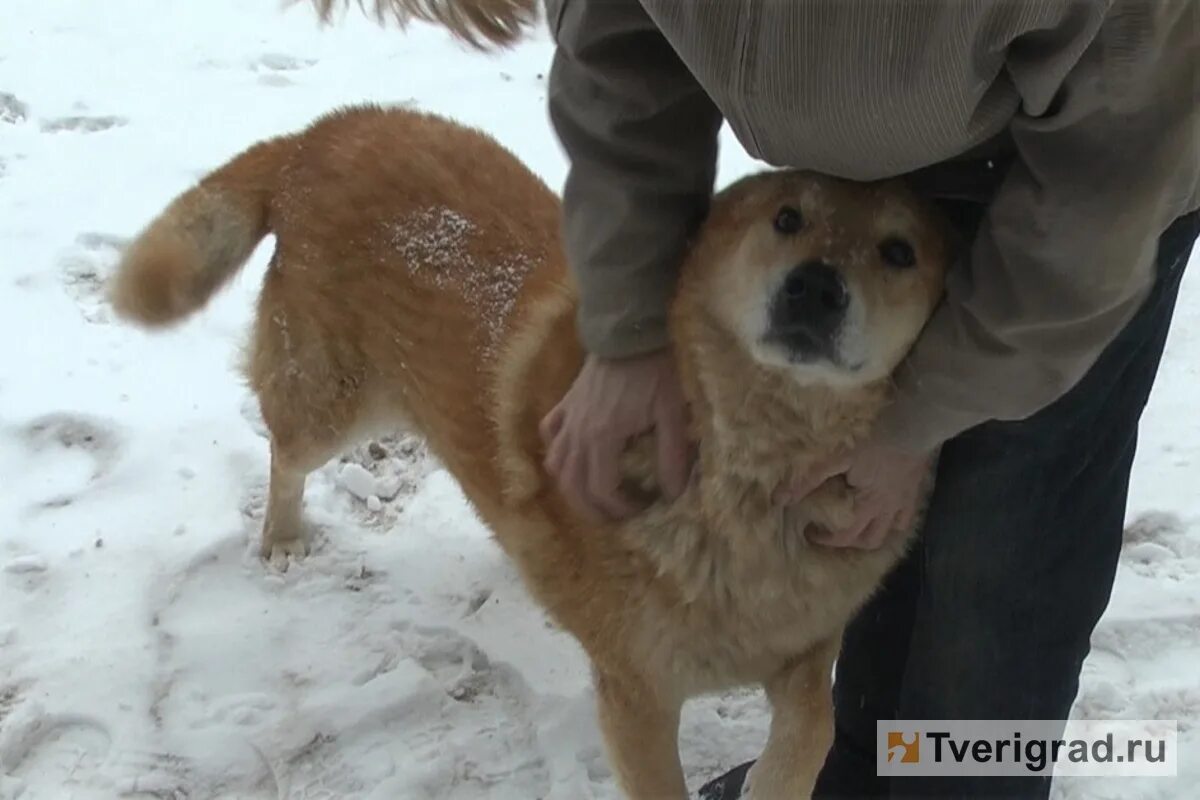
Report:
547,0,721,357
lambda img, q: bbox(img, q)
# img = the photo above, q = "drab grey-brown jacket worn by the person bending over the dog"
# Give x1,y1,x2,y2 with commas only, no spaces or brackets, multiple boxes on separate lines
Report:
547,0,1200,449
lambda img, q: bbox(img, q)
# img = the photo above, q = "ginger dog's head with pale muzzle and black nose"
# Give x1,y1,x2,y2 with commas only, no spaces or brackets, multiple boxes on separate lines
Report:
682,172,950,387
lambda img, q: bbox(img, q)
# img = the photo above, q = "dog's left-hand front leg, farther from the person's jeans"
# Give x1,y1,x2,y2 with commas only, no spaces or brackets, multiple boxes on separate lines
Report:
596,670,688,800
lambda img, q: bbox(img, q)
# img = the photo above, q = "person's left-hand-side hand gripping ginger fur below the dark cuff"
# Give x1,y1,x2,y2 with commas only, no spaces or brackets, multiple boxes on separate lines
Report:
539,350,689,519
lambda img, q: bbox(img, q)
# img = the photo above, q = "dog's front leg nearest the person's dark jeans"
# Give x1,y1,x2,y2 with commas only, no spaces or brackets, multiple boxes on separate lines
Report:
748,634,841,800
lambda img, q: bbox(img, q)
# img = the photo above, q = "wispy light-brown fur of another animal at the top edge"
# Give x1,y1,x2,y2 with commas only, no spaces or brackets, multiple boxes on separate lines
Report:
312,0,541,50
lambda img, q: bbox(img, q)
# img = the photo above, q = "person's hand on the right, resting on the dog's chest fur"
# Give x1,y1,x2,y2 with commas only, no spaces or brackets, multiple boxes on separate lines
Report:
775,441,932,551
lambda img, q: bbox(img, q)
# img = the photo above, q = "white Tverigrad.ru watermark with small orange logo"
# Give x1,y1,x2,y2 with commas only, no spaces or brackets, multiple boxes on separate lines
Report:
876,720,1178,777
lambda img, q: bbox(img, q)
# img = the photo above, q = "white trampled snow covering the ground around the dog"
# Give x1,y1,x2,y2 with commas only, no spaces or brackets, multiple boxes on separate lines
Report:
0,0,1200,800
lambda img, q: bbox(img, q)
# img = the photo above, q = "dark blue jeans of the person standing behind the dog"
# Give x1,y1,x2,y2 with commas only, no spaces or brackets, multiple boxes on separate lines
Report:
702,208,1200,799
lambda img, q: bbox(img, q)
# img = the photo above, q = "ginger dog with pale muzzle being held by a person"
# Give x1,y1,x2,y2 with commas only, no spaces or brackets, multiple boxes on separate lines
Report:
112,97,949,800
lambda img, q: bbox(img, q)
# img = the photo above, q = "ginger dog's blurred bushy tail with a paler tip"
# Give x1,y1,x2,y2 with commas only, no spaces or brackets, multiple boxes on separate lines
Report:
109,137,292,327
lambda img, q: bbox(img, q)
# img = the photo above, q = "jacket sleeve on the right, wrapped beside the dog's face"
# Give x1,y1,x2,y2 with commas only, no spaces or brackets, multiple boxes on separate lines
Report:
877,0,1200,451
